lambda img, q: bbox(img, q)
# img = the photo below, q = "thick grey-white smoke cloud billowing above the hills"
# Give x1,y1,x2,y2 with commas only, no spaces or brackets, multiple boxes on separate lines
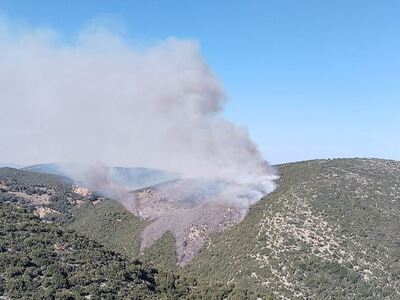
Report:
0,22,274,188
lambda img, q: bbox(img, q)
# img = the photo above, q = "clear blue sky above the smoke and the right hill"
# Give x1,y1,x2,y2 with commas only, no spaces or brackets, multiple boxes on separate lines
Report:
0,0,400,163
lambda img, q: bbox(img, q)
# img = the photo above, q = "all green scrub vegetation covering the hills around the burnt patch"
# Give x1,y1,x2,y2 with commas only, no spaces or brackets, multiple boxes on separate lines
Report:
0,159,400,299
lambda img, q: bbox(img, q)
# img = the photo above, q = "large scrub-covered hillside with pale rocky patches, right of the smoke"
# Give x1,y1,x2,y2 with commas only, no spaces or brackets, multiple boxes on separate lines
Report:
187,159,400,299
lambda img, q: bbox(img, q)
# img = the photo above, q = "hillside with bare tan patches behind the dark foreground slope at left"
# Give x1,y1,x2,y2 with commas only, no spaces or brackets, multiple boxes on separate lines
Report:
0,168,175,267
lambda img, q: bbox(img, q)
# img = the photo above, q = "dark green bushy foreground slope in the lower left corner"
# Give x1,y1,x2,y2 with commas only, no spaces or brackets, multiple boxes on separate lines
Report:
0,202,260,299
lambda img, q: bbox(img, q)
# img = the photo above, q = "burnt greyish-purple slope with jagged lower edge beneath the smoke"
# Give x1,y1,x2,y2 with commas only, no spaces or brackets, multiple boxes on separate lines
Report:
132,179,252,266
